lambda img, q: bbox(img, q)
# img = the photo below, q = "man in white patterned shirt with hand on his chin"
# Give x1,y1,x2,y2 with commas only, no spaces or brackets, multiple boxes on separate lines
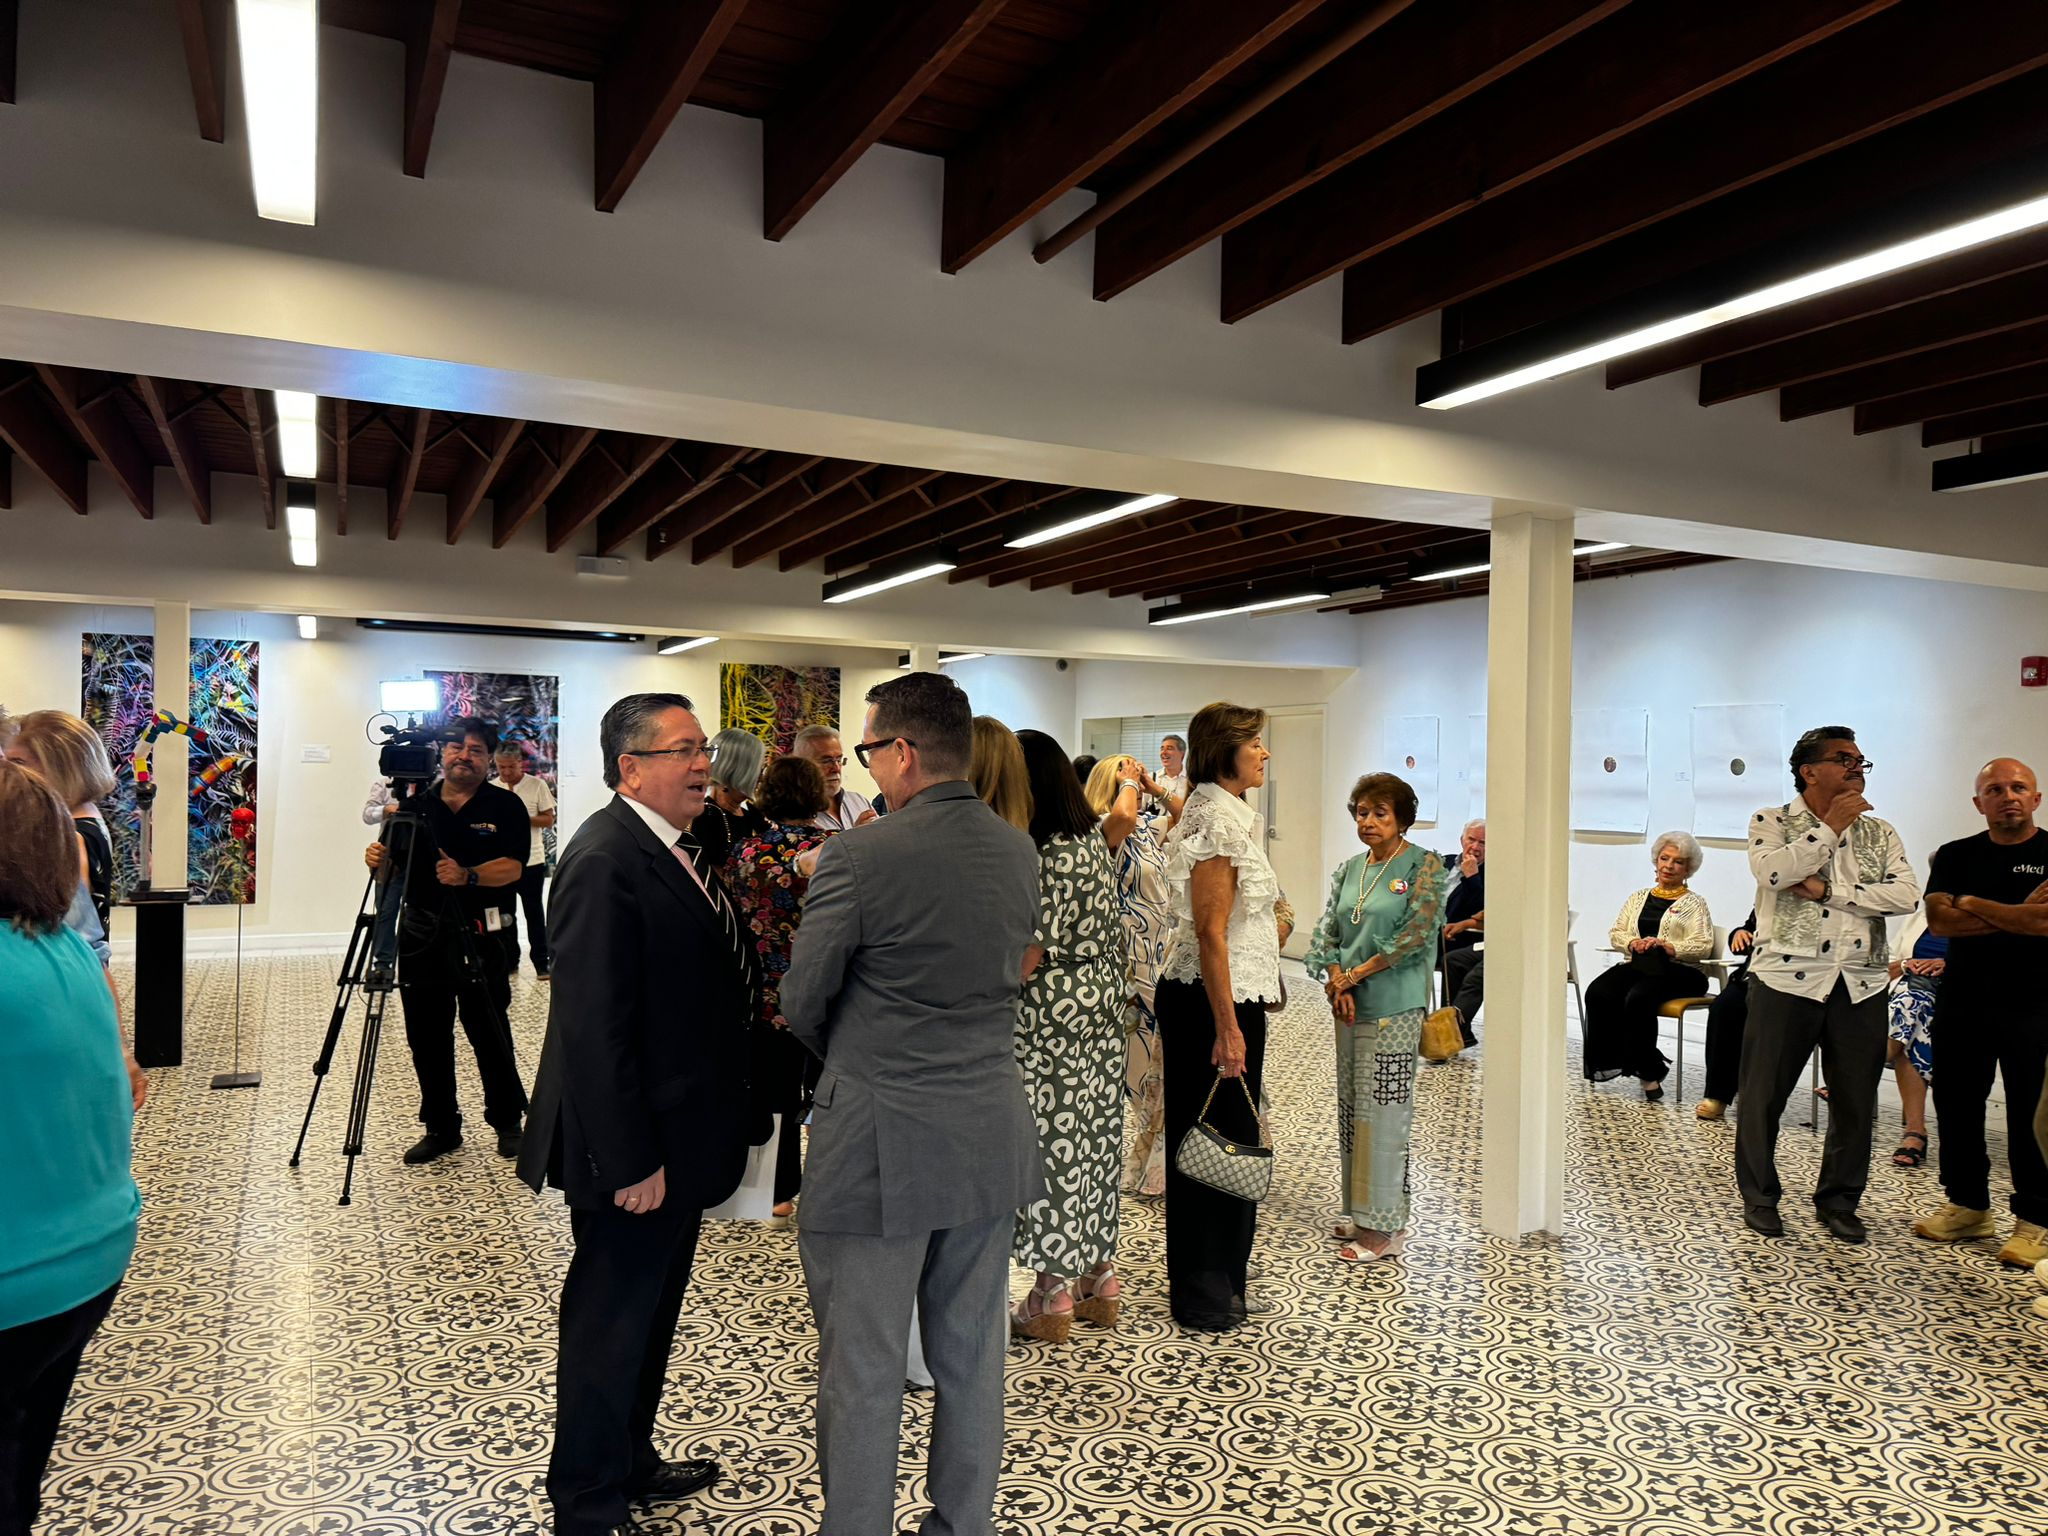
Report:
1735,725,1919,1243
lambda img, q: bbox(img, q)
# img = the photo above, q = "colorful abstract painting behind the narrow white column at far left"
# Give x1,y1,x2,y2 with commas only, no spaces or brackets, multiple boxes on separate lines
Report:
80,633,258,905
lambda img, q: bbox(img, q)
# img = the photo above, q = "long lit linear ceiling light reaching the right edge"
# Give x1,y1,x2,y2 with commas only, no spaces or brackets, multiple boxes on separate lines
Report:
1415,186,2048,412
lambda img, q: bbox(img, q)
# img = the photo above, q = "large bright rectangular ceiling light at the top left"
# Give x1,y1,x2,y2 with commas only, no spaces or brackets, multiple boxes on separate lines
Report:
236,0,319,223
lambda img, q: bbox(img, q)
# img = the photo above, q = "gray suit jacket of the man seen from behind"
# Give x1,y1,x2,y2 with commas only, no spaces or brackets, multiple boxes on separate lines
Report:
782,780,1044,1237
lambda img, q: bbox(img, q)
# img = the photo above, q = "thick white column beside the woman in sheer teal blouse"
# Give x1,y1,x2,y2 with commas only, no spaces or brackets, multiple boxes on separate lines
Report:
1481,502,1573,1237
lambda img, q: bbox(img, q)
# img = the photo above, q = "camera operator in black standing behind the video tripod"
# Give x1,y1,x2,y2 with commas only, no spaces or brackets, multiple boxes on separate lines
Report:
365,719,530,1163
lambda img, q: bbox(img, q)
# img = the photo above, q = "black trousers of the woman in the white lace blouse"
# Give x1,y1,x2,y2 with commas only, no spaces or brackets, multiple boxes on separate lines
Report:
1155,981,1266,1333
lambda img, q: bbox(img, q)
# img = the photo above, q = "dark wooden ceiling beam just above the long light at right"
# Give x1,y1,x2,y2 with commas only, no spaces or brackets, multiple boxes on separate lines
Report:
1343,0,2048,342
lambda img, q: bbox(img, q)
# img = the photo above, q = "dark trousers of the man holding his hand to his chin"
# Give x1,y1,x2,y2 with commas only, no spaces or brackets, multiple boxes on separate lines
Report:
1735,981,1875,1210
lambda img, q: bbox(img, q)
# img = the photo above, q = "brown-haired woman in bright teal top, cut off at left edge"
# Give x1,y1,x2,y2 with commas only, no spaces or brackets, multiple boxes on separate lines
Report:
0,760,141,1532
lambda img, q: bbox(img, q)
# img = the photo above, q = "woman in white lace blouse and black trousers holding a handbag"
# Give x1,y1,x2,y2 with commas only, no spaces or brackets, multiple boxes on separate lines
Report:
1155,705,1284,1333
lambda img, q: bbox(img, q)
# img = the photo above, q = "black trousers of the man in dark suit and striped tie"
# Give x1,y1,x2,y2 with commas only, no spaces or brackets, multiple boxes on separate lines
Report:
547,1194,705,1536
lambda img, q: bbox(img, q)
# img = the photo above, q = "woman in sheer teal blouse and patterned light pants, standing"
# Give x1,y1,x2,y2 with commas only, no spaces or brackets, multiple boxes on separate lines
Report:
1309,774,1444,1264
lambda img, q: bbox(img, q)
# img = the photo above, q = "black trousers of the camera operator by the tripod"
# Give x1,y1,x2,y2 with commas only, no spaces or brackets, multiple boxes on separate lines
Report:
399,934,526,1137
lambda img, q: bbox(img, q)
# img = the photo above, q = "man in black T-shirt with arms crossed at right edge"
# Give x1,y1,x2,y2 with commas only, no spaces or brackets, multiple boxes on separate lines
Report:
1913,758,2048,1266
